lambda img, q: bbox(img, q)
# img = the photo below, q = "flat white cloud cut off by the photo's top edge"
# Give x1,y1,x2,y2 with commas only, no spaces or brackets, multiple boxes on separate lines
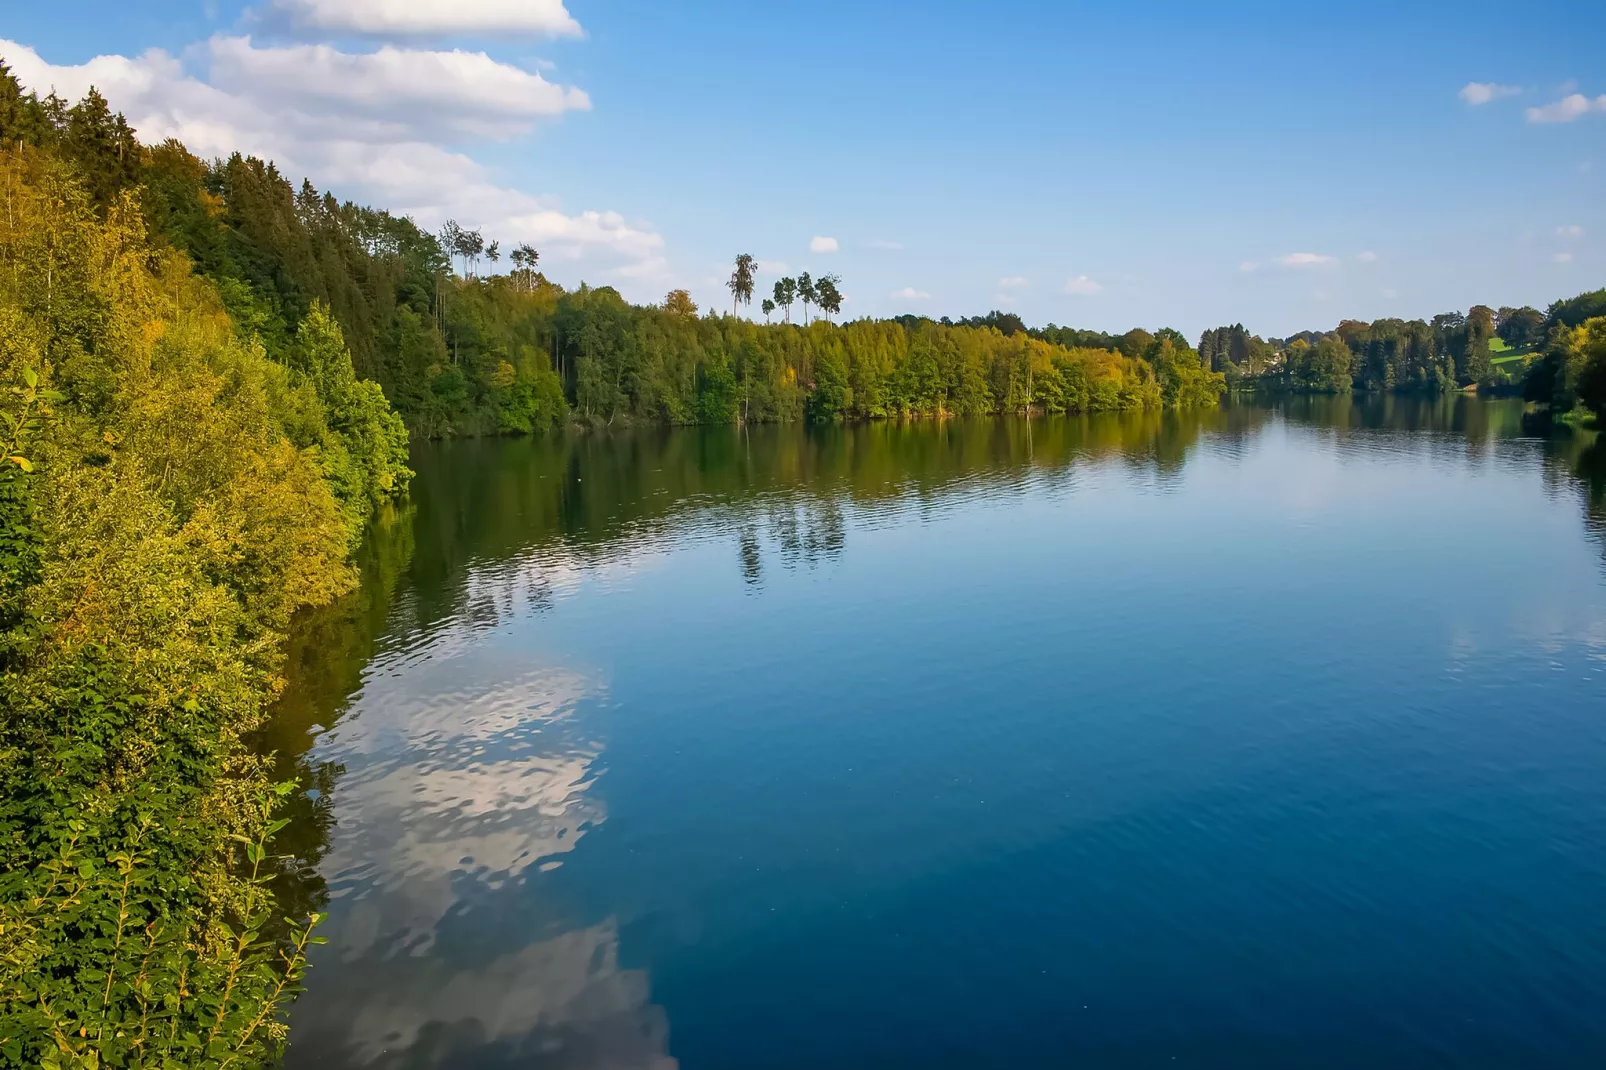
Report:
273,0,583,37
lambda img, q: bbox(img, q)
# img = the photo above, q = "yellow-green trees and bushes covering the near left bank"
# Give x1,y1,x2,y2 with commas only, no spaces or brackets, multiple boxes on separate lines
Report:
0,77,411,1067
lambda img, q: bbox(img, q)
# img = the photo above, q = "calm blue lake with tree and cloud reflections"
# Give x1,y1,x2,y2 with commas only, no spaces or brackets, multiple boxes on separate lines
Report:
270,397,1606,1070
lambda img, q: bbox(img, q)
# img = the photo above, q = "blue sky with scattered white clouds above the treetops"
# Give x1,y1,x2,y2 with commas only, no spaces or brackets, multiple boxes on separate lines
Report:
0,0,1606,337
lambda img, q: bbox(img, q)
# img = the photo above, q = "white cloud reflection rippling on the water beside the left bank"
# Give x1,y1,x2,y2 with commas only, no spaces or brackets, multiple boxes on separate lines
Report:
289,607,675,1068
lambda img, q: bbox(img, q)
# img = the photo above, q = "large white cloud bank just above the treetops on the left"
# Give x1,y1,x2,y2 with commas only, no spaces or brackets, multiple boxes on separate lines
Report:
0,37,665,278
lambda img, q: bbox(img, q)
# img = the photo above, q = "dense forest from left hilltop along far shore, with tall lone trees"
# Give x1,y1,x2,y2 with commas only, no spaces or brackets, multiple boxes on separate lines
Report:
0,66,1214,435
